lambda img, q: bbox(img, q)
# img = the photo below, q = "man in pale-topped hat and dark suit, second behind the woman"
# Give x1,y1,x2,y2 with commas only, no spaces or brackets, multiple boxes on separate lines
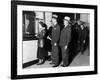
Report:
59,16,71,67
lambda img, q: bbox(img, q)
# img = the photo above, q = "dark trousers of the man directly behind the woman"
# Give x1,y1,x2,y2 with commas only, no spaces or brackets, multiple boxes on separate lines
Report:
51,46,59,65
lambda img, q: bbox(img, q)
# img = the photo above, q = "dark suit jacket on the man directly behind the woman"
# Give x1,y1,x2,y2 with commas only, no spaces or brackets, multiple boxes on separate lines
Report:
51,24,60,45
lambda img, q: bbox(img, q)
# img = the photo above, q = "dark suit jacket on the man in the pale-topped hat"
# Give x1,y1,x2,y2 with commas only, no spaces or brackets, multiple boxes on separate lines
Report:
59,26,71,46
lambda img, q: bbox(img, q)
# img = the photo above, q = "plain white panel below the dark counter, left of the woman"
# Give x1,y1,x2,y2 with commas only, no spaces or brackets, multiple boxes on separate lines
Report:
23,40,37,63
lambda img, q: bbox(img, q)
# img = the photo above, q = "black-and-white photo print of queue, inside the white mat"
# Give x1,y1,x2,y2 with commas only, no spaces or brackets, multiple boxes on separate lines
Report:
22,11,90,69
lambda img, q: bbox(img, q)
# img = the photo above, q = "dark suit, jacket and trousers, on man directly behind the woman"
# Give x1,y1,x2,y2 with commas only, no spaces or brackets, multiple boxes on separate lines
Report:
51,24,60,65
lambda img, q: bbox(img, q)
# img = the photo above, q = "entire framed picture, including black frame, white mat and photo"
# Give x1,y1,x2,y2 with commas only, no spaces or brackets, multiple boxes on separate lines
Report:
12,1,97,78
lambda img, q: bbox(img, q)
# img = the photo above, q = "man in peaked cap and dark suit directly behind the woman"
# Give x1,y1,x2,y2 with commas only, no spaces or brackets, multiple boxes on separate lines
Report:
50,15,60,67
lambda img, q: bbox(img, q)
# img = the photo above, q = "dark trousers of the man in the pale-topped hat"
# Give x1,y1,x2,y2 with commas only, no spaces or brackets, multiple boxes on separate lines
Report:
61,46,69,66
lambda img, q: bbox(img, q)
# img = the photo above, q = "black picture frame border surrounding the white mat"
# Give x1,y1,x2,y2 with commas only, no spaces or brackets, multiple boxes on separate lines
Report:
11,1,98,79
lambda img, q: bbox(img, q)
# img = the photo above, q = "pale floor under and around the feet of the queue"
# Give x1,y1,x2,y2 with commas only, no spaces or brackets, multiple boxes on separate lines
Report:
26,49,90,69
